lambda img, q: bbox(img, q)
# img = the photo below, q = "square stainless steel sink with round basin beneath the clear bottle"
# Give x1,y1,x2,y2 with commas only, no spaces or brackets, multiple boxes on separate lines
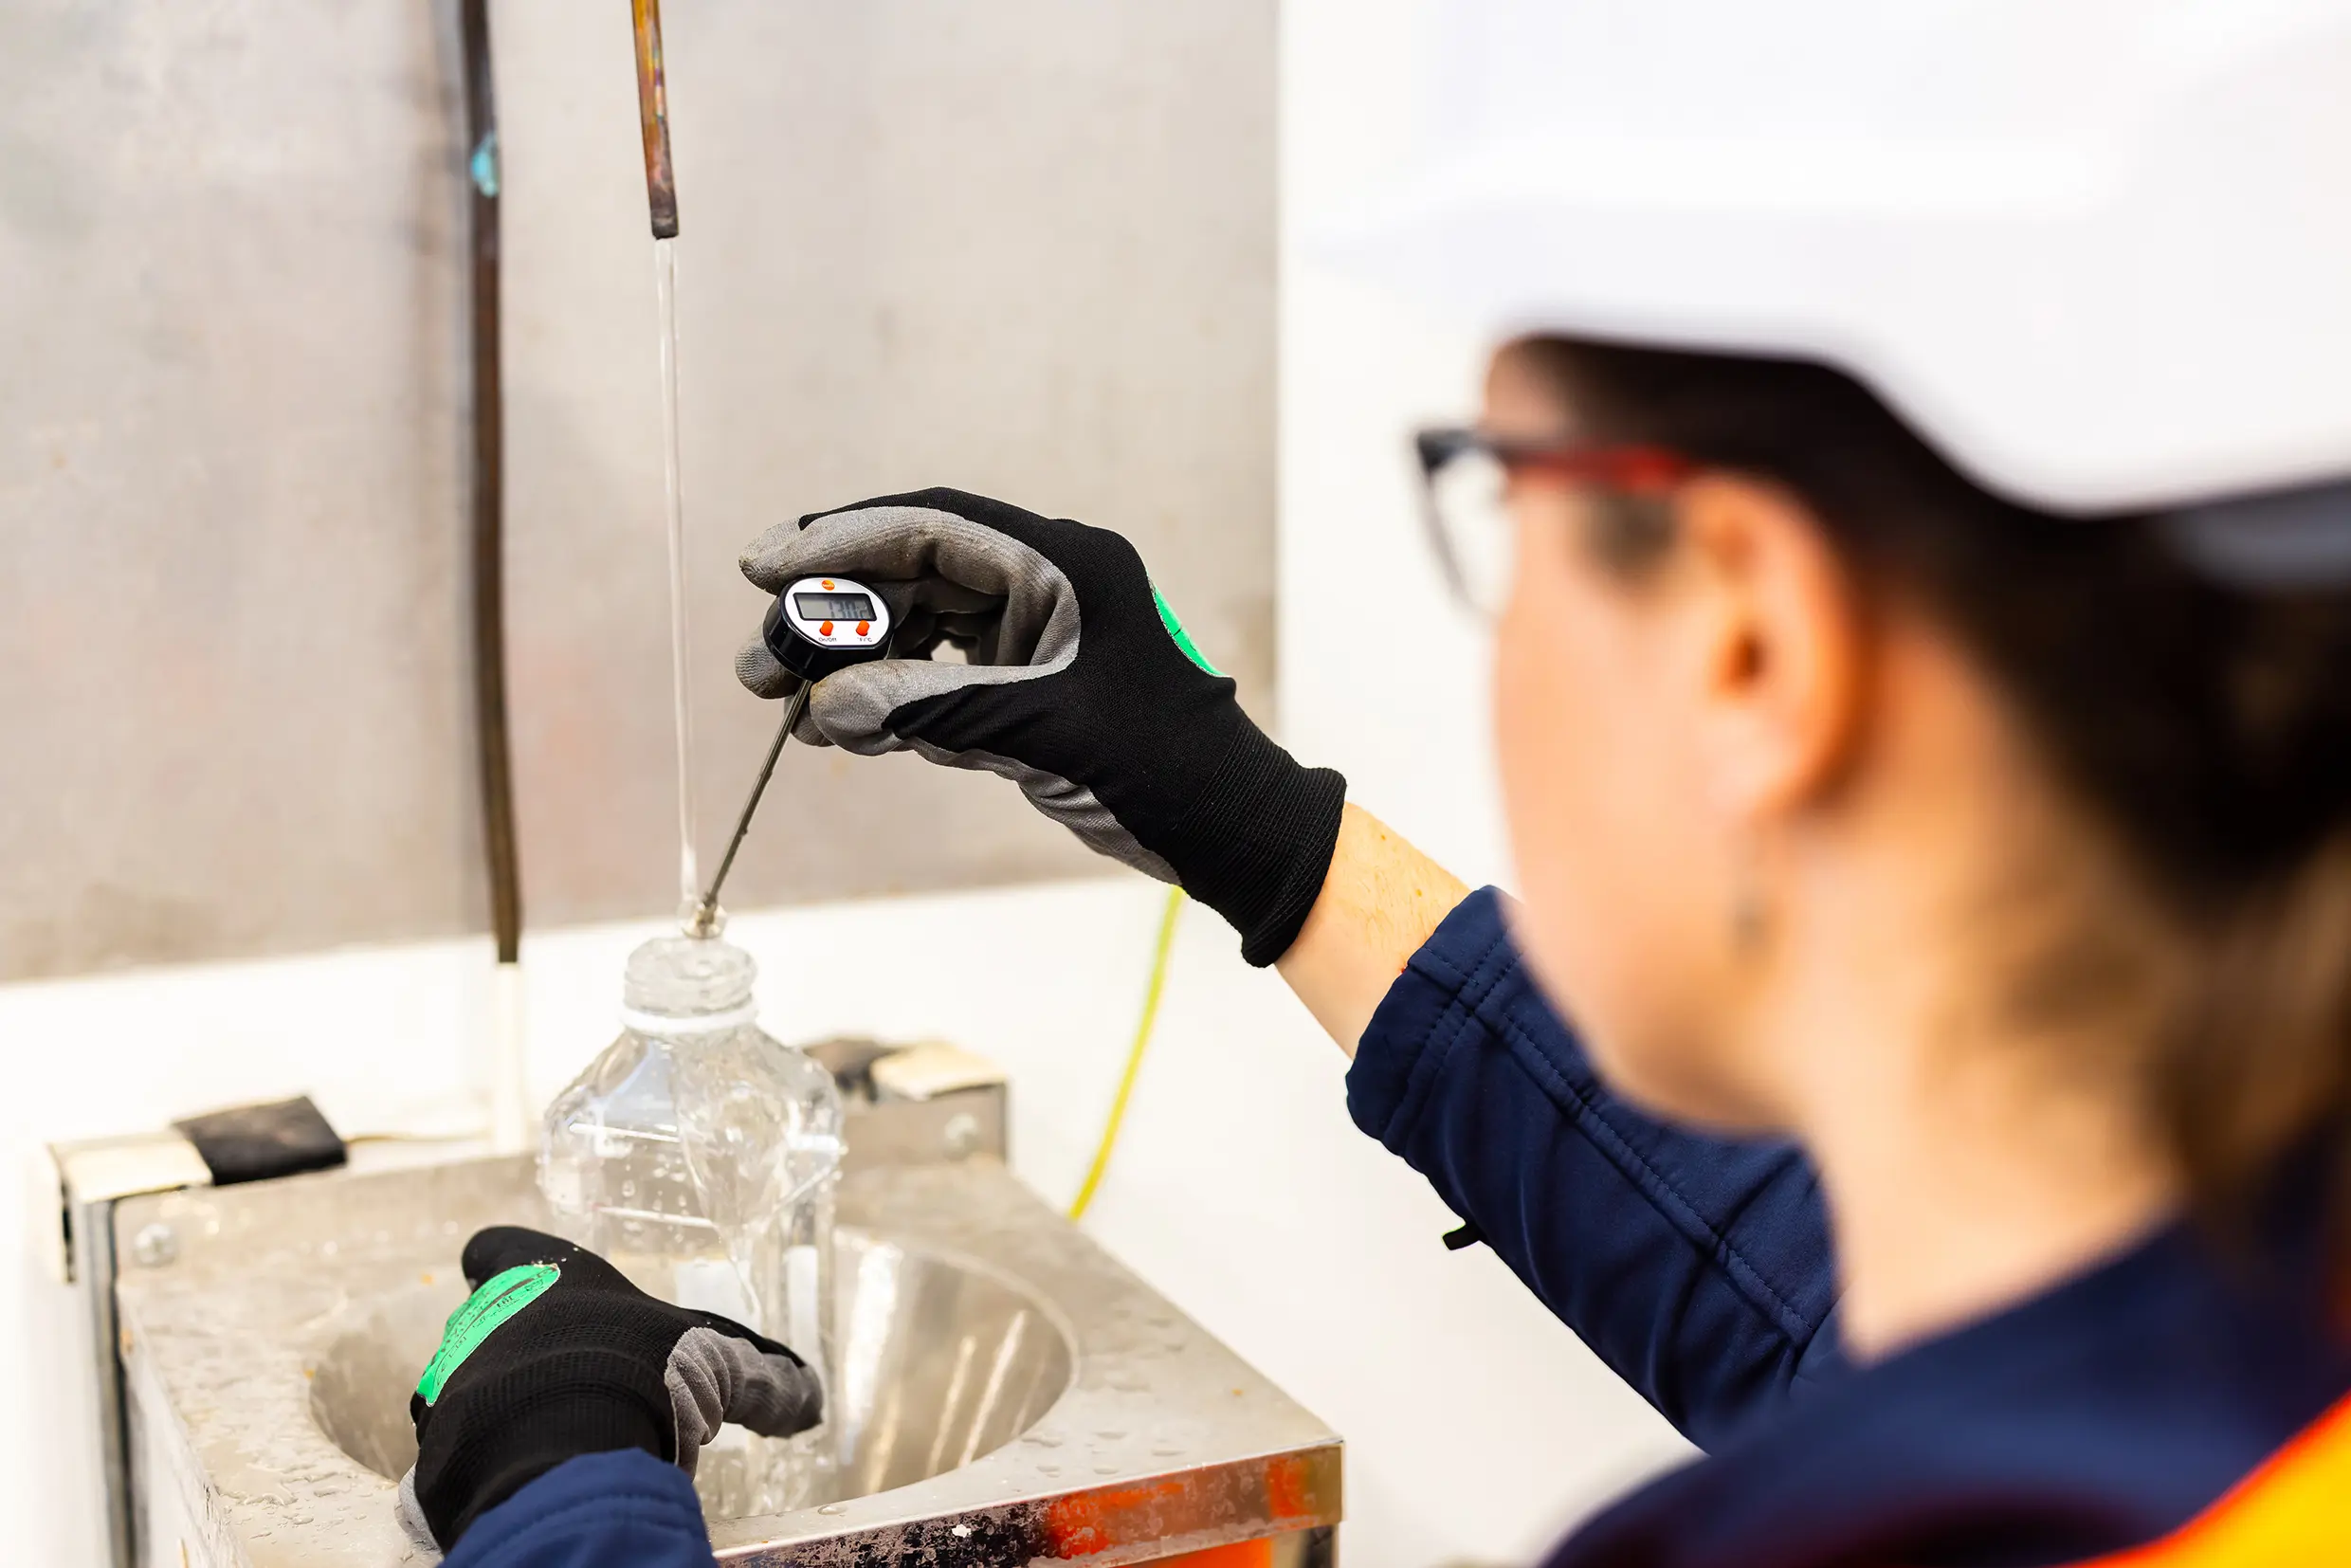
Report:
96,1104,1340,1568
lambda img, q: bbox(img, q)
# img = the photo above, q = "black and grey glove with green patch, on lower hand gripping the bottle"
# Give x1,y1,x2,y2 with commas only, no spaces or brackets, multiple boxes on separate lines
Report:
400,1225,823,1552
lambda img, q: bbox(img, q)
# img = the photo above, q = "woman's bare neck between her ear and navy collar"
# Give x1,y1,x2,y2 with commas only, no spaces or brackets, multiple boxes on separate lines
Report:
1752,611,2179,1358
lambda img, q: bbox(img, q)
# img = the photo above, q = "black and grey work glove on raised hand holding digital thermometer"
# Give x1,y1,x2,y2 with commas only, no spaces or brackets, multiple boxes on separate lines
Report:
736,489,1347,964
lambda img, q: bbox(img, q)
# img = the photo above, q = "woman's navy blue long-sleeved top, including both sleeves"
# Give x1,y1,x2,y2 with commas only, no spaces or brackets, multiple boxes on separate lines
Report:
449,888,2351,1568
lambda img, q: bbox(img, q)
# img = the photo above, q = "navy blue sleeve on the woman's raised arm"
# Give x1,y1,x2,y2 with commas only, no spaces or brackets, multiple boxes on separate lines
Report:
1347,888,1843,1449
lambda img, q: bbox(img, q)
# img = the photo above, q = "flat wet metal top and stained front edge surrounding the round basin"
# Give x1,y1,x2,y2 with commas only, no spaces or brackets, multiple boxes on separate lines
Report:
116,1157,1340,1568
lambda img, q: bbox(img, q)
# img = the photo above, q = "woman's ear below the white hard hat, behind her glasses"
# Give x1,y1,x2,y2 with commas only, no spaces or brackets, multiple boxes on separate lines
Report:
1676,472,1867,820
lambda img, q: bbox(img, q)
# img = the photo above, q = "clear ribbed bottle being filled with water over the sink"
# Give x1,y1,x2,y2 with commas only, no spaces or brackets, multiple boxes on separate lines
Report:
538,936,842,1519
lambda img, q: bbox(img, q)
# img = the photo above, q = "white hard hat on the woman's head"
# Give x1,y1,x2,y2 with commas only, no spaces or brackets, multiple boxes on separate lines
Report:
1321,0,2351,513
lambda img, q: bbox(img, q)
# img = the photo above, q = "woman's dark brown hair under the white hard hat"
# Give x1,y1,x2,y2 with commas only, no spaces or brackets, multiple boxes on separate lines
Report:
1512,338,2351,1263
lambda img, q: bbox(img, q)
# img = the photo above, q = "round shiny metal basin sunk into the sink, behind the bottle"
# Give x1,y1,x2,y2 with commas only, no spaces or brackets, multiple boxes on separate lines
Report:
305,1230,1074,1498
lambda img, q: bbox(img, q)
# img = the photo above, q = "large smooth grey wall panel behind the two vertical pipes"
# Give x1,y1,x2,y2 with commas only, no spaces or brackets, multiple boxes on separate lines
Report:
0,0,1274,978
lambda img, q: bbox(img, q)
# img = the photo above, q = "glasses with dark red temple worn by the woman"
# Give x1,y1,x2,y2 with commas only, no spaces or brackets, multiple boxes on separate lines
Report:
1412,426,1698,618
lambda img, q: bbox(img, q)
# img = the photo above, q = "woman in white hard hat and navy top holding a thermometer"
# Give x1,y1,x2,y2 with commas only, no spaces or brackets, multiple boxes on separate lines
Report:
416,7,2351,1568
